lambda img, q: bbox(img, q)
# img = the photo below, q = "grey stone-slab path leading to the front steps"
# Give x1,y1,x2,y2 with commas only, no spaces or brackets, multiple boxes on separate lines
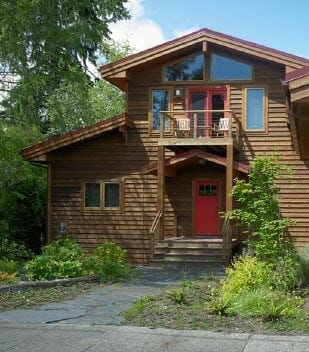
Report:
0,267,215,325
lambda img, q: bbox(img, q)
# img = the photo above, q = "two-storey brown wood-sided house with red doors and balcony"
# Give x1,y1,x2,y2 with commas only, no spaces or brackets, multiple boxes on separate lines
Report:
22,29,309,264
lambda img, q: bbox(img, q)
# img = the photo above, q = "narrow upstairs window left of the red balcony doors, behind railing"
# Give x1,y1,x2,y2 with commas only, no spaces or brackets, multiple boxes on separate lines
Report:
151,89,170,132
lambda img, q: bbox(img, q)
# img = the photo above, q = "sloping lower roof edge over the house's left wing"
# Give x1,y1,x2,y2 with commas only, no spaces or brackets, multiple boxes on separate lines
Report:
21,113,134,162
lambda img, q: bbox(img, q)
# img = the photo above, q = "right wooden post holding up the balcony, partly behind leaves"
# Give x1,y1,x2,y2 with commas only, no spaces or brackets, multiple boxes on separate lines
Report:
223,144,233,260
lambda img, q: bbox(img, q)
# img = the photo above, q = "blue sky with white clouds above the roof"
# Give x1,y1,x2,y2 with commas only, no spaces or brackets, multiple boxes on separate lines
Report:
110,0,309,58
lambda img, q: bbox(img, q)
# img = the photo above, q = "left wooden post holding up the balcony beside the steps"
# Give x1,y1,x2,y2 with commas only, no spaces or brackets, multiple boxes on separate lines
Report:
157,145,165,241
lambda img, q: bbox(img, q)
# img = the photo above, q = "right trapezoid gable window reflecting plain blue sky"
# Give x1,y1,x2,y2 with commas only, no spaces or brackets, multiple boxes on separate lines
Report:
210,54,252,81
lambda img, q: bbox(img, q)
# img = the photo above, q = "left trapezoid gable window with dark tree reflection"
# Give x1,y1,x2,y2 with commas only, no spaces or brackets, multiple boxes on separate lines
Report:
163,54,204,81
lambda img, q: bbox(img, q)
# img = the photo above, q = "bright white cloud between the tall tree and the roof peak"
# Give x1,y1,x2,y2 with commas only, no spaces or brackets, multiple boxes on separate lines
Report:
110,0,165,52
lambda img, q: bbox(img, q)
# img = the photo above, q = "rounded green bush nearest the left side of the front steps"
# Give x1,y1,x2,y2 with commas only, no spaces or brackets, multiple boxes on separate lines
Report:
84,242,129,281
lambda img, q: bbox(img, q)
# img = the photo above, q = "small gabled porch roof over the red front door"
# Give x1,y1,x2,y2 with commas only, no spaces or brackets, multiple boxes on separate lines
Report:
143,149,250,174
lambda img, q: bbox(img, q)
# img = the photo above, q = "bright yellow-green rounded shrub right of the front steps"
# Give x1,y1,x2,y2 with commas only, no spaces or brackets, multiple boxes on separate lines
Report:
221,255,272,302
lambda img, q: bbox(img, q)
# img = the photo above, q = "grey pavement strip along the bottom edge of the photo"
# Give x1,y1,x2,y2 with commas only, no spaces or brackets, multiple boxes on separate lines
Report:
0,323,309,352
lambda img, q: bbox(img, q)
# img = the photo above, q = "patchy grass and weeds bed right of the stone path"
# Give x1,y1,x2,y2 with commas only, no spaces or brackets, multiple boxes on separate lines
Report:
123,279,309,334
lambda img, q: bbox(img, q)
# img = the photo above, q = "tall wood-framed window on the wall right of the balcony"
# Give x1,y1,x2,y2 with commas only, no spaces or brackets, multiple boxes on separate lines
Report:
245,88,266,131
